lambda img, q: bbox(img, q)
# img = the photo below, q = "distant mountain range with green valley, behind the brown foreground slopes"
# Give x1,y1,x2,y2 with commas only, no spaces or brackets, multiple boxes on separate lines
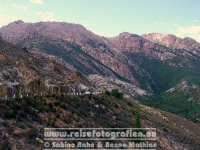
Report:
0,20,200,121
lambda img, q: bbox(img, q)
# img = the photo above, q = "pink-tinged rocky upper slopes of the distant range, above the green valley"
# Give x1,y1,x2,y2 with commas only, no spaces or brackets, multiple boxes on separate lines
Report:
0,21,200,96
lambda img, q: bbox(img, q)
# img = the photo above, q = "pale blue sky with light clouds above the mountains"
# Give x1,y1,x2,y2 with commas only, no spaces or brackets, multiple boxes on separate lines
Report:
0,0,200,42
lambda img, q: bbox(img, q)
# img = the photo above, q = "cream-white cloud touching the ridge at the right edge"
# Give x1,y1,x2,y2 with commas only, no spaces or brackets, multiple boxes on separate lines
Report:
176,26,200,41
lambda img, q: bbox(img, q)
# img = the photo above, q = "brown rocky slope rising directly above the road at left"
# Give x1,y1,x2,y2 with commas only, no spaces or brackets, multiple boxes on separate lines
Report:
0,40,92,98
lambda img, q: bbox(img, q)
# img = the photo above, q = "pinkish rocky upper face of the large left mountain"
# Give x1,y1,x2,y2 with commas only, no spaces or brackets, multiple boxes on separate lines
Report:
0,21,141,80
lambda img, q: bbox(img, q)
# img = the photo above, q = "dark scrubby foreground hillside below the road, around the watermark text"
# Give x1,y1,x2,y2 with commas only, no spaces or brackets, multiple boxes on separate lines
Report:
0,95,200,150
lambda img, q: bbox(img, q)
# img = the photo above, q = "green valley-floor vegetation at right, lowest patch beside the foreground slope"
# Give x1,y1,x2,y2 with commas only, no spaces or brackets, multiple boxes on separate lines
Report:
141,92,200,122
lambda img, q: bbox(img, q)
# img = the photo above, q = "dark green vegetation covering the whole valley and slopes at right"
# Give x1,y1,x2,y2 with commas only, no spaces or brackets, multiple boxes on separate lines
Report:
130,55,200,122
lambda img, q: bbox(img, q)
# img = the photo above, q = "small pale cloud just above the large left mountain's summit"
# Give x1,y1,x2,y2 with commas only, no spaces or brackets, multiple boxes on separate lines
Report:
36,11,56,21
